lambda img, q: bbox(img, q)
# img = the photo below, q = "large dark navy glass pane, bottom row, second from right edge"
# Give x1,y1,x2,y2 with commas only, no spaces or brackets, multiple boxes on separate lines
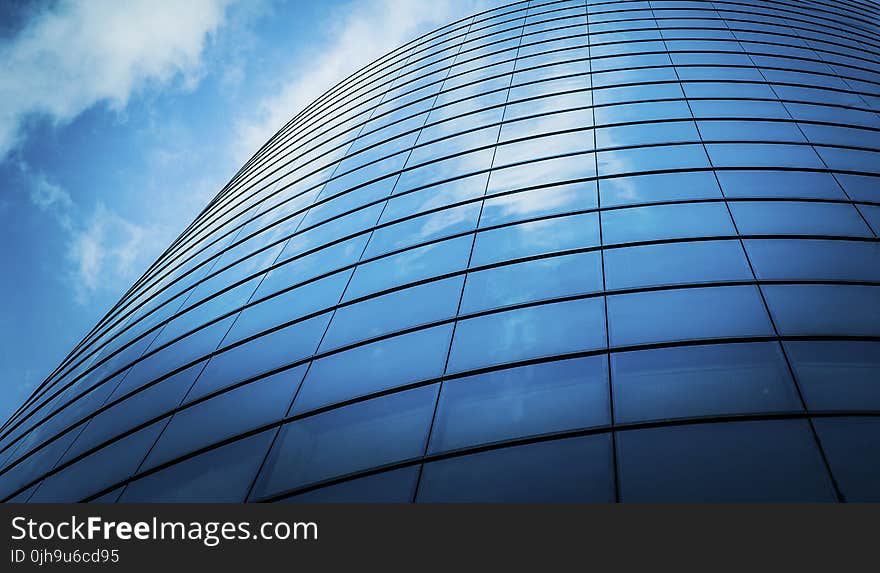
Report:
617,420,835,502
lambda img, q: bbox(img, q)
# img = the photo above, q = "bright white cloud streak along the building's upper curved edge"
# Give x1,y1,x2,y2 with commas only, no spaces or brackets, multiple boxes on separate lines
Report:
232,0,498,163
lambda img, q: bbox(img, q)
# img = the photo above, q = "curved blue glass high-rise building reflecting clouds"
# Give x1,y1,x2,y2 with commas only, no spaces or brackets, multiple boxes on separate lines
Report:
0,0,880,502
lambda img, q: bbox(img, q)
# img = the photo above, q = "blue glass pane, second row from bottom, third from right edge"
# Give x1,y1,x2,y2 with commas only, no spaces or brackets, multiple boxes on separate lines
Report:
428,355,610,453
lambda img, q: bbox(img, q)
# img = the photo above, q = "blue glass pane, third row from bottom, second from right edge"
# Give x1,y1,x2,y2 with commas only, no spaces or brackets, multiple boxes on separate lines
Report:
608,286,773,346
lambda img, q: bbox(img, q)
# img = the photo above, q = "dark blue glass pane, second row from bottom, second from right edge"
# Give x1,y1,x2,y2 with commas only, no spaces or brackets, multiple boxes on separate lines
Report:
611,342,802,423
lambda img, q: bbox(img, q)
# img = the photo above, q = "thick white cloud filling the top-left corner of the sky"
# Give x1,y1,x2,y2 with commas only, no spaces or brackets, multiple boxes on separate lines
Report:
0,0,231,159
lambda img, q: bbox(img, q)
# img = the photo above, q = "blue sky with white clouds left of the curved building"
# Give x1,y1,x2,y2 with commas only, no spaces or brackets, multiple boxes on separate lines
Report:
0,0,488,420
